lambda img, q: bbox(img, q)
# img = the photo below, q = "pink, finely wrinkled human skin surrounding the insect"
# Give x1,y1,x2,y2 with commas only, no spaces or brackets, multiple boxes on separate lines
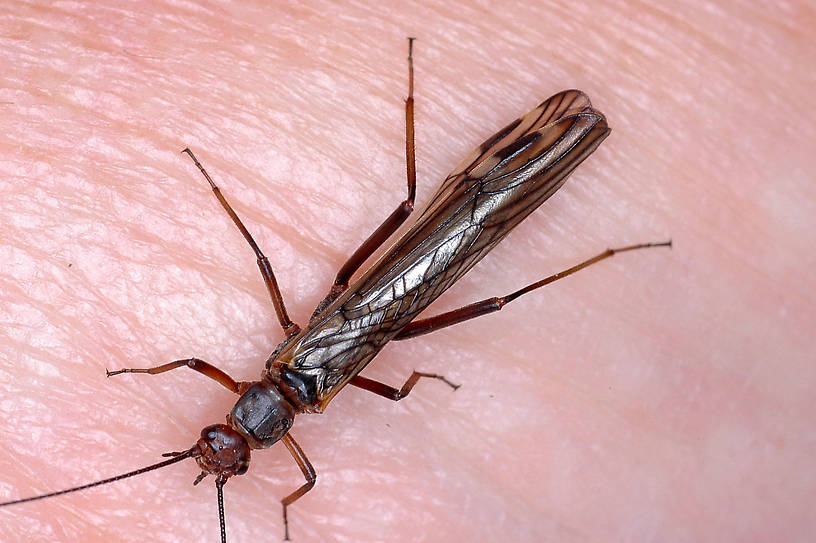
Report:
0,2,816,542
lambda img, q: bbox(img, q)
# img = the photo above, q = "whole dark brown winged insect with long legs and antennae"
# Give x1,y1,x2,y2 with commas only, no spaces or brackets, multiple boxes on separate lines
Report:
0,38,671,541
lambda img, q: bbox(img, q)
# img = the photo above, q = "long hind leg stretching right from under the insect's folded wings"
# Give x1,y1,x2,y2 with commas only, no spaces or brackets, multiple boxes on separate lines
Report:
394,240,671,340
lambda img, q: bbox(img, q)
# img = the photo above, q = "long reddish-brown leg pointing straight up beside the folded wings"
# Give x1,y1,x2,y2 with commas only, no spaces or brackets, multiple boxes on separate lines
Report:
315,38,416,314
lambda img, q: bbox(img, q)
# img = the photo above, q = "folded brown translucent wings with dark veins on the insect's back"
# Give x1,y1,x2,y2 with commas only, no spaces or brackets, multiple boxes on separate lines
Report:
289,90,609,406
